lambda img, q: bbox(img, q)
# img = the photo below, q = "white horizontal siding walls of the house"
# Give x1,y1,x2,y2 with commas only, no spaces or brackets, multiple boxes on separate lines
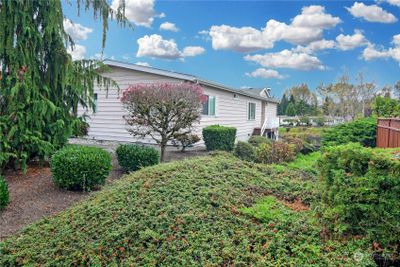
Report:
79,67,276,146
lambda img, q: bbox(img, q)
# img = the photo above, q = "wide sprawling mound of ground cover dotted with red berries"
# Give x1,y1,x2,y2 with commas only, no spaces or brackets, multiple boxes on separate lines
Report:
0,153,363,266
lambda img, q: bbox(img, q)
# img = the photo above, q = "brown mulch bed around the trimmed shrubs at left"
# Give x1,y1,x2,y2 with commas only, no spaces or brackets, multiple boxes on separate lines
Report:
0,149,208,241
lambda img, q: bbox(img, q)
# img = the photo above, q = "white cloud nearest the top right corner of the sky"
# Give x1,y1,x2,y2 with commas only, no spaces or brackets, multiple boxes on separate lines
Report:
346,2,397,23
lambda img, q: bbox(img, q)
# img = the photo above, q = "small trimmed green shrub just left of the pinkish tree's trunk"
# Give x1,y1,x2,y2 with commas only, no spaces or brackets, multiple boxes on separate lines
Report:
116,144,160,172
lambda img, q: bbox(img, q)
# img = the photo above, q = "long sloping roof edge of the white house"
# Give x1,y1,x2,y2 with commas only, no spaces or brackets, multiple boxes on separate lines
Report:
103,59,279,103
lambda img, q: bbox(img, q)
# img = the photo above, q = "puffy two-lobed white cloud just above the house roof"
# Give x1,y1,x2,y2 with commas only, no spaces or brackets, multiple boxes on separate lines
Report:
136,34,205,59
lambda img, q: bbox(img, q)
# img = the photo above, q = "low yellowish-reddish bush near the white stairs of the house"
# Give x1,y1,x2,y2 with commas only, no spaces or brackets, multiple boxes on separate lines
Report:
257,141,296,163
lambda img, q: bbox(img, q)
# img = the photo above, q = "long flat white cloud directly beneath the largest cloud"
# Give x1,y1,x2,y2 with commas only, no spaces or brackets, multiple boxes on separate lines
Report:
244,49,325,70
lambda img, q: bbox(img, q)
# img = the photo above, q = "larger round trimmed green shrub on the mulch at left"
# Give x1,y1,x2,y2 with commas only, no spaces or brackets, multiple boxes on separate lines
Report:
50,146,112,191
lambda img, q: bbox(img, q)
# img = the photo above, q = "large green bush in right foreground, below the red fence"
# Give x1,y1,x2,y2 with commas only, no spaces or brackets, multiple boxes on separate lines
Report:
318,143,400,250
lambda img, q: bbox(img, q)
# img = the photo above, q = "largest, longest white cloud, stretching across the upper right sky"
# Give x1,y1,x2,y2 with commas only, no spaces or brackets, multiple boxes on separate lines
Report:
206,5,341,52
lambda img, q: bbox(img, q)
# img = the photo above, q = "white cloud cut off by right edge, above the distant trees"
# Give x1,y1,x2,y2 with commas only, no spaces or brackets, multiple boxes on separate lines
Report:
362,34,400,63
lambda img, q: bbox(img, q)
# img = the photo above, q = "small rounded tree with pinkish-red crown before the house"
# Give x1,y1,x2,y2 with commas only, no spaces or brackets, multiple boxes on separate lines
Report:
121,83,206,161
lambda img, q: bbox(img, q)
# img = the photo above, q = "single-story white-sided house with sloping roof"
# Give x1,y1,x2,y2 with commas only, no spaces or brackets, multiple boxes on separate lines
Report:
79,60,279,146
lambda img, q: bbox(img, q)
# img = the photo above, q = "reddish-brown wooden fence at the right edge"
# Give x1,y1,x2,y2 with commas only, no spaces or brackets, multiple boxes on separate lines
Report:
376,118,400,148
